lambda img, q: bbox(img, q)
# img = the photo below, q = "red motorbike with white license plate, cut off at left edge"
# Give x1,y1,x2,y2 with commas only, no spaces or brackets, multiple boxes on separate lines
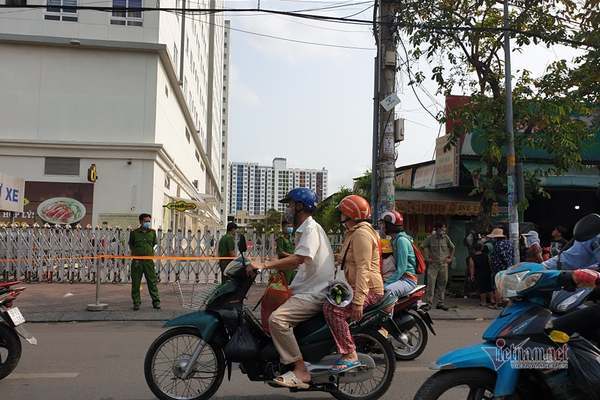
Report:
0,281,37,379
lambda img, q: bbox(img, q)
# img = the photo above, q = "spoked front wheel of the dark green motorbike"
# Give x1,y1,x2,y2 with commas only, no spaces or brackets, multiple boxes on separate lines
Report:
144,327,225,400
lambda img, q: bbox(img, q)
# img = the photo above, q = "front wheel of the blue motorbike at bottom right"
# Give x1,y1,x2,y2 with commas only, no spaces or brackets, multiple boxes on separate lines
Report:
414,368,496,400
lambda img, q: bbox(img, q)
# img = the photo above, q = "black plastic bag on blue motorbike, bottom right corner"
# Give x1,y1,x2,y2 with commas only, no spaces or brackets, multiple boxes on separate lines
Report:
568,335,600,400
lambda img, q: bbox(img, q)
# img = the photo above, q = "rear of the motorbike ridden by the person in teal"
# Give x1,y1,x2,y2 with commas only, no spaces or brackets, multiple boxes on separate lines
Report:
385,285,436,361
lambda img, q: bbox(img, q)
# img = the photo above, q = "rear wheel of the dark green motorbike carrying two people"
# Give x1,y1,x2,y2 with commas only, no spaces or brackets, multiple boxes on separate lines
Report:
331,331,396,400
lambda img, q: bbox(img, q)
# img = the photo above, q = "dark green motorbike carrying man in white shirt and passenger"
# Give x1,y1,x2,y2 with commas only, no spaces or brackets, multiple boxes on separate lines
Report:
144,238,397,400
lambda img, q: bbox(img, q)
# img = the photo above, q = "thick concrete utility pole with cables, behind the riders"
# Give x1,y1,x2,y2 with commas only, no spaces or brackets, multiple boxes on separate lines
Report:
373,0,398,220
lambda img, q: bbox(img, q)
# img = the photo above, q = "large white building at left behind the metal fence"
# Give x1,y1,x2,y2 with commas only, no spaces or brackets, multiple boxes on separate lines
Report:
0,0,227,230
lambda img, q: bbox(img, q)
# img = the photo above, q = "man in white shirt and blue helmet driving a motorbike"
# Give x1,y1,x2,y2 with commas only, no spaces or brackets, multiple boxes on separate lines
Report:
248,188,335,389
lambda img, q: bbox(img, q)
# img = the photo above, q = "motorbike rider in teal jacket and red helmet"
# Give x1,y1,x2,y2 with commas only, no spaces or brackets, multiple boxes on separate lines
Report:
379,210,417,297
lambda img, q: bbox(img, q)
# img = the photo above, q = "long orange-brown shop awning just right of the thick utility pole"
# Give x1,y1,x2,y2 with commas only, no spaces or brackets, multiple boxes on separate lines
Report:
396,190,498,216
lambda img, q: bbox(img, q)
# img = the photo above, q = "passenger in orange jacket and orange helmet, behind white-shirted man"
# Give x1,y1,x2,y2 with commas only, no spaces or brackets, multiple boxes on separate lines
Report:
323,195,383,373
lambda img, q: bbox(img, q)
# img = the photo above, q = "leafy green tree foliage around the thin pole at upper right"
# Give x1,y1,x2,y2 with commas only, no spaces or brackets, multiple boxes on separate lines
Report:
398,0,600,222
